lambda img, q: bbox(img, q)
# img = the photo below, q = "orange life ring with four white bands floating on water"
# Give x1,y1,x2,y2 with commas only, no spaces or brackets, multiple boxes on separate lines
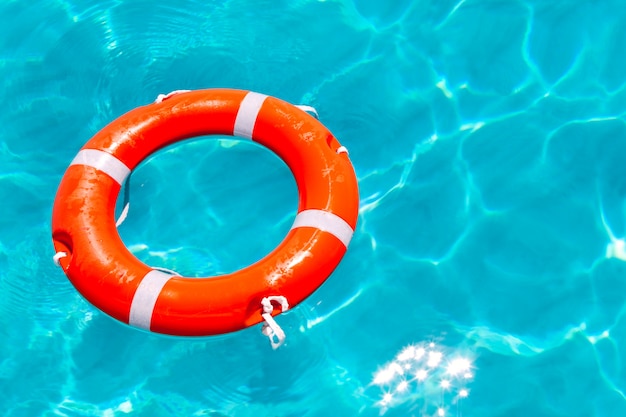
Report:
52,89,358,336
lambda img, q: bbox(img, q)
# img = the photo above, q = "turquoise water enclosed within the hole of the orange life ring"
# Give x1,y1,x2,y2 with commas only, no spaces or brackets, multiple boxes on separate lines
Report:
116,136,298,277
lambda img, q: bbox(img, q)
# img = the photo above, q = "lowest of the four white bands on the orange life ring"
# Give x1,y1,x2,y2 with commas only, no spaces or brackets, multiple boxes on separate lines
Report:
128,269,175,330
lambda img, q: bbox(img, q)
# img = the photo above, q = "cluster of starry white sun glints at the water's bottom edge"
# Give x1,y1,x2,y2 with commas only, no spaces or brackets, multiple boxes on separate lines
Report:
372,342,474,417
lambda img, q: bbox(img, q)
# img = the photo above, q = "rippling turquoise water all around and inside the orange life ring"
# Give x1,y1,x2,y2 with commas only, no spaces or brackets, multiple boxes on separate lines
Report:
0,0,626,417
